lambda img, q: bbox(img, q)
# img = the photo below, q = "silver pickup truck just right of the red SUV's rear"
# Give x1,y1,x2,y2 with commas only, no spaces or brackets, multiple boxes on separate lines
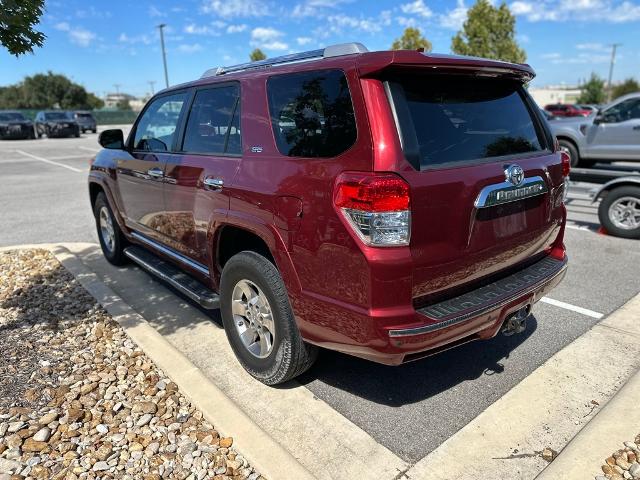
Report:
551,92,640,167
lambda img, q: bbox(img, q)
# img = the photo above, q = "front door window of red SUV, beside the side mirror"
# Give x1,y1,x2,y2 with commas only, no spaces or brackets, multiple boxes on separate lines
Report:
133,93,187,152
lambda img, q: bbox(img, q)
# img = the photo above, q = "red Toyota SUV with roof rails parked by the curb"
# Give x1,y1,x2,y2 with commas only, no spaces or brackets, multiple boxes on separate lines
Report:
89,43,569,384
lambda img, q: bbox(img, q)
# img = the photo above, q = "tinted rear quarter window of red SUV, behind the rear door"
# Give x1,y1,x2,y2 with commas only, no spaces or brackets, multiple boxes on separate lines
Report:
267,70,356,157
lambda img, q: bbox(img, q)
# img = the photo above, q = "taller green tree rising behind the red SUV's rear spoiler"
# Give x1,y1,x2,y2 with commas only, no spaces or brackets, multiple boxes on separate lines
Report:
451,0,527,63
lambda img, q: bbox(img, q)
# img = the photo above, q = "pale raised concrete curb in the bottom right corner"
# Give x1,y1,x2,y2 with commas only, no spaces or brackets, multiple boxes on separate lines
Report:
536,373,640,480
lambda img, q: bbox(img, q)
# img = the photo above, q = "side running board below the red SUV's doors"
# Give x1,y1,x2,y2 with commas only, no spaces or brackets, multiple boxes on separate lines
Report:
124,246,220,309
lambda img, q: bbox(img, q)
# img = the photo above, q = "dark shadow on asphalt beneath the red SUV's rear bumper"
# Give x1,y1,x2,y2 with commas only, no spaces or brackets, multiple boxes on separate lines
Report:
297,314,538,407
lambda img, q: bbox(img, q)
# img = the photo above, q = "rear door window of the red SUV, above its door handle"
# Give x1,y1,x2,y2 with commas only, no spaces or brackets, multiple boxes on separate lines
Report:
182,85,242,154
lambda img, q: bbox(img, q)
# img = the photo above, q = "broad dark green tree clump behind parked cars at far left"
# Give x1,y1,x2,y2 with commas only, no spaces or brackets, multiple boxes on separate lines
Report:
0,72,102,110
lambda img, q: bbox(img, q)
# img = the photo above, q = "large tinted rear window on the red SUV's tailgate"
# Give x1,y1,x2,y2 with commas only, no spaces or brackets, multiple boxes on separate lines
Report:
390,75,544,168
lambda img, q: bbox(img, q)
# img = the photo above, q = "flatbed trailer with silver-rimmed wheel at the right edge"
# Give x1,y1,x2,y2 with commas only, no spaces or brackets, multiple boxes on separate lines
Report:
569,166,640,239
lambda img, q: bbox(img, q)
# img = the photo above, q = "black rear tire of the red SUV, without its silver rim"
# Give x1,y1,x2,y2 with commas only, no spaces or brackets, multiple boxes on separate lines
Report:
220,251,318,385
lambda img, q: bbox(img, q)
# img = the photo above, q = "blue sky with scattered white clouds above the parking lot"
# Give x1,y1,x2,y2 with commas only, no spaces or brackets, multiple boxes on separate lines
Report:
0,0,640,95
